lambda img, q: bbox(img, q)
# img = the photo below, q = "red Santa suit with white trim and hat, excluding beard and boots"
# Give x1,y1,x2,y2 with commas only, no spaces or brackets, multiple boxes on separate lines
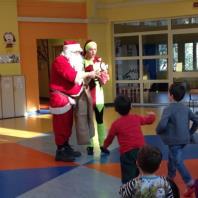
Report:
50,41,83,145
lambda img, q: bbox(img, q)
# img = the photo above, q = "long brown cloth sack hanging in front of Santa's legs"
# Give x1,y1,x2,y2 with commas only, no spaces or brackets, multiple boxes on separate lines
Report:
74,91,95,145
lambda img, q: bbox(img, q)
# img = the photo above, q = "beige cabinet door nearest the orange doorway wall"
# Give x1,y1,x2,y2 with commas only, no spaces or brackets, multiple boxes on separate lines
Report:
13,76,26,117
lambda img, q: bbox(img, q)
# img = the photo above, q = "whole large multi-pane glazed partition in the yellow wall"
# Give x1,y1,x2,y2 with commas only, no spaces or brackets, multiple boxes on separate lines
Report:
114,16,198,104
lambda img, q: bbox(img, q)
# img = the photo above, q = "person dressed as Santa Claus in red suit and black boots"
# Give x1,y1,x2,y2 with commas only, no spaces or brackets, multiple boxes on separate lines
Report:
50,41,95,161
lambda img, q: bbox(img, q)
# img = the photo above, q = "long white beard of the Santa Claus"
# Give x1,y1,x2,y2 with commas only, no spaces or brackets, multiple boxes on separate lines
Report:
62,50,84,72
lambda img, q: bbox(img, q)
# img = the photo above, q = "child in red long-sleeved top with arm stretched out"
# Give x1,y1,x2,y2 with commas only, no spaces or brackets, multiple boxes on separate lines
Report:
103,96,155,183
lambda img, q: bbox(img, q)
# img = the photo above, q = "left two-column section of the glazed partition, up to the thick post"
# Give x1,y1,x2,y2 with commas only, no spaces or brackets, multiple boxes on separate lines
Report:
114,20,169,104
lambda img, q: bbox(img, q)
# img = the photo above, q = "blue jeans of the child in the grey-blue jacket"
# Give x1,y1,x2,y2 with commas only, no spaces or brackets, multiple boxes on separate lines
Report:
168,145,192,185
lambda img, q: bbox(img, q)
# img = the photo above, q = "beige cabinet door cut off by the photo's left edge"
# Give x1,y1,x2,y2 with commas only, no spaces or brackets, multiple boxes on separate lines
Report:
1,76,15,118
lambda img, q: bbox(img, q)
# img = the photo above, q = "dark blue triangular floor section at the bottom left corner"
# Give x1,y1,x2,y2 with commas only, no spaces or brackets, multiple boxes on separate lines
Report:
0,166,75,198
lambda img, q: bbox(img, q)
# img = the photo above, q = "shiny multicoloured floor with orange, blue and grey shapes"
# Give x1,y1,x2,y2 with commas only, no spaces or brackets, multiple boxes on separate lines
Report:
0,107,198,198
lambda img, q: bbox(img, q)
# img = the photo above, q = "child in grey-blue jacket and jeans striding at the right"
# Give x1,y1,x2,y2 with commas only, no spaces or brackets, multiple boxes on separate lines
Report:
156,83,198,196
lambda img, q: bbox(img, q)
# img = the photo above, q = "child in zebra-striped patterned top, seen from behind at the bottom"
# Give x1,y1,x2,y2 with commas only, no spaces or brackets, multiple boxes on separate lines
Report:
119,145,173,198
